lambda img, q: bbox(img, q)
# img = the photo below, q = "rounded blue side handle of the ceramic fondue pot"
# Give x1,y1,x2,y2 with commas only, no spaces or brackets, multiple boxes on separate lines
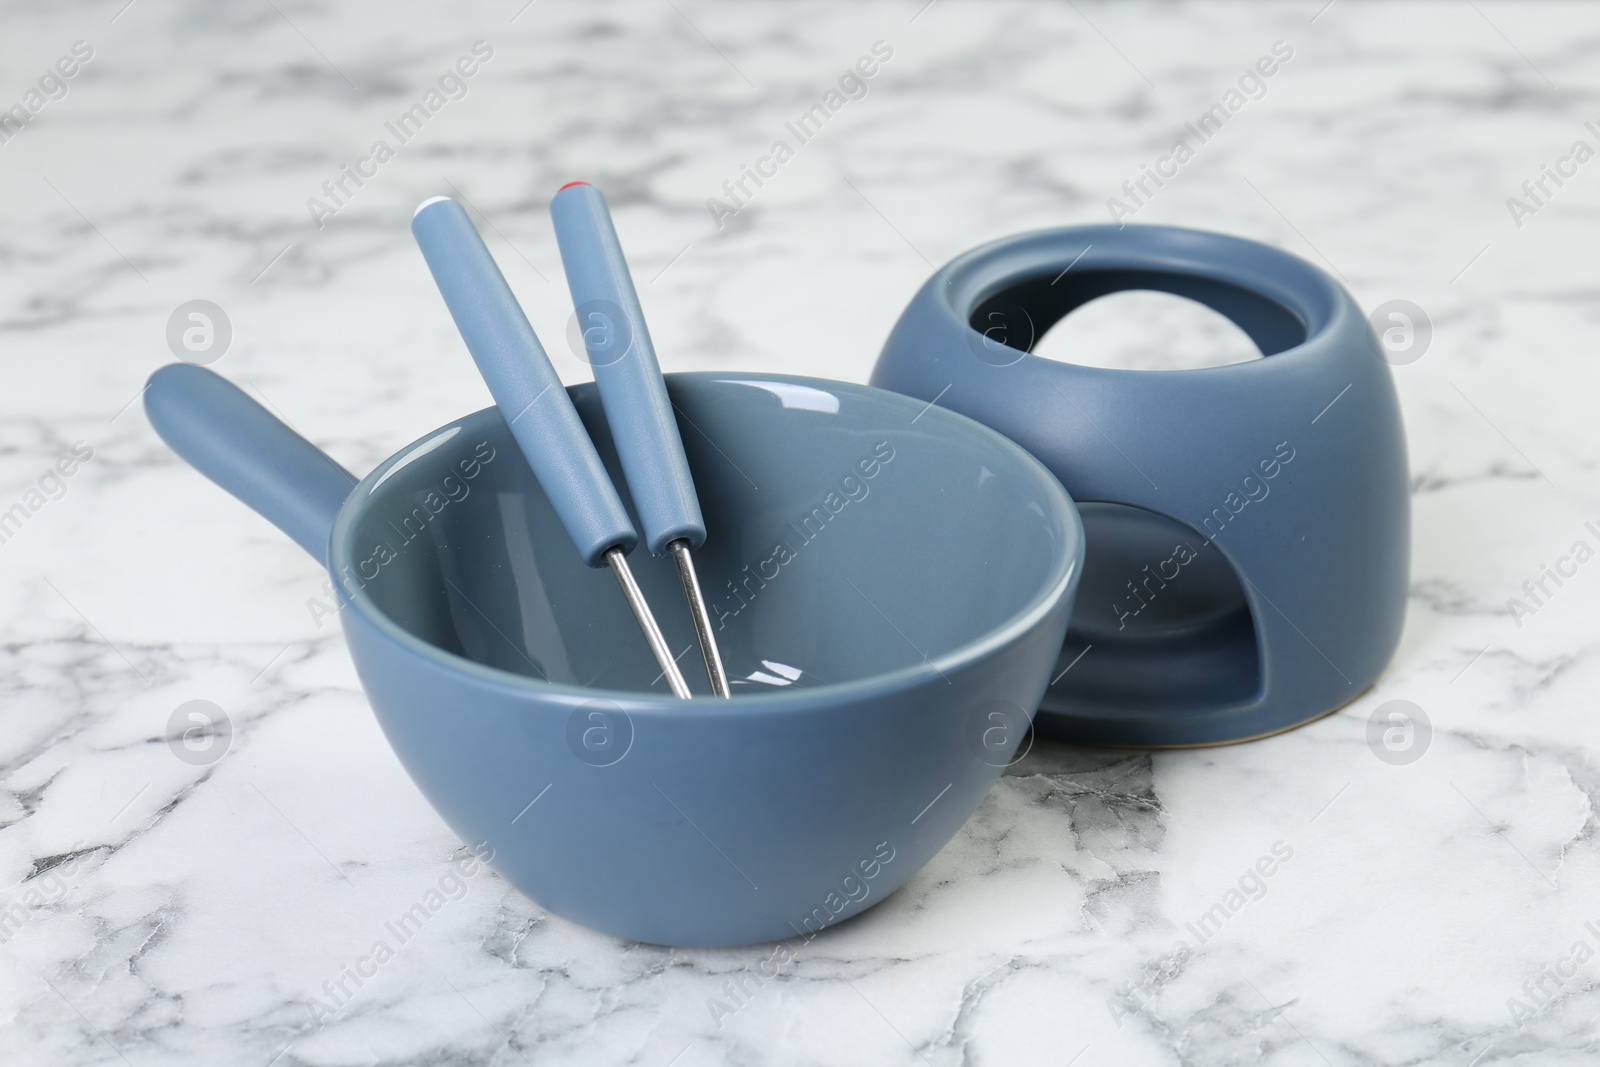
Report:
144,363,357,563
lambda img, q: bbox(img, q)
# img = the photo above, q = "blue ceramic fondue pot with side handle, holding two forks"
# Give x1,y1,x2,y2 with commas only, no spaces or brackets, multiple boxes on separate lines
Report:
146,365,1083,945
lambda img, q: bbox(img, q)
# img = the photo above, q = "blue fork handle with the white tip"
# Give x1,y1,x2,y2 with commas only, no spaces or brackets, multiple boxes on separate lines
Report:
411,197,638,566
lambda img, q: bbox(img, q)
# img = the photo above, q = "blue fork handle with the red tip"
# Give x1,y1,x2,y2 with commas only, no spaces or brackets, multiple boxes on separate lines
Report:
550,182,706,555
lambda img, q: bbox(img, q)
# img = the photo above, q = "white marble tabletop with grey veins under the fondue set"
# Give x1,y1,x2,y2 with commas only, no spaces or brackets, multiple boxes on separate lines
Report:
0,0,1600,1067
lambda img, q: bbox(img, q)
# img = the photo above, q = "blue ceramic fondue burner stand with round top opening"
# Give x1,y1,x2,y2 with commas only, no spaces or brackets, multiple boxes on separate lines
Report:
872,226,1411,745
